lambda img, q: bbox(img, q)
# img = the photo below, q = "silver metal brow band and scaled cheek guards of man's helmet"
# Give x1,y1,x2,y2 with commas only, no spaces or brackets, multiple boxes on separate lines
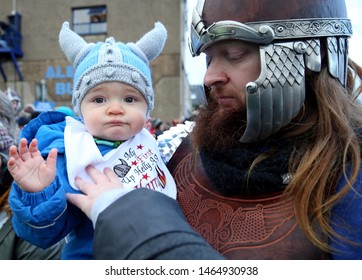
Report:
190,0,352,143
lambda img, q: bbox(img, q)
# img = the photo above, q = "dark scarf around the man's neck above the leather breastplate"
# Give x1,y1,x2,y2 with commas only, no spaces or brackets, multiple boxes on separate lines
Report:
200,141,295,195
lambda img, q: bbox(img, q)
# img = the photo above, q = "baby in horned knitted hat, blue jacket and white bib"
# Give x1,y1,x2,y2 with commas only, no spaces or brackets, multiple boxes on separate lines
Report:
8,22,176,259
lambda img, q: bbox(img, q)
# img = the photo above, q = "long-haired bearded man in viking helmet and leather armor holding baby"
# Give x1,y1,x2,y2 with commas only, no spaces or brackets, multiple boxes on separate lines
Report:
69,0,362,259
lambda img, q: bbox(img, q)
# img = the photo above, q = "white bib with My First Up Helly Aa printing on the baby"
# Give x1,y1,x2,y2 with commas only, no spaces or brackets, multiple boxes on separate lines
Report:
64,117,176,199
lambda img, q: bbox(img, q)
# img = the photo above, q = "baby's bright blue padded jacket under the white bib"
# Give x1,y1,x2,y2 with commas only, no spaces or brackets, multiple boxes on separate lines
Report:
9,111,110,259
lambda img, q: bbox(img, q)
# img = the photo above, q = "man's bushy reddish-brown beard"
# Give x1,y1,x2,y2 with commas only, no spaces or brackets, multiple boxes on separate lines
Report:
192,100,246,151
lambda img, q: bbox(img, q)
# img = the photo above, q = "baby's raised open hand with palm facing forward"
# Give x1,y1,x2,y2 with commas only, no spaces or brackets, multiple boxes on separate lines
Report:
8,138,58,192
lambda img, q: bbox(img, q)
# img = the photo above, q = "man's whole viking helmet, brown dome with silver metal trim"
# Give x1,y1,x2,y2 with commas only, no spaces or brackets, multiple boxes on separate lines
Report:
190,0,352,143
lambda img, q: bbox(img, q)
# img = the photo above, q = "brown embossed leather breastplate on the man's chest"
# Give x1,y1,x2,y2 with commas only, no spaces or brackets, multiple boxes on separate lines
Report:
168,138,326,259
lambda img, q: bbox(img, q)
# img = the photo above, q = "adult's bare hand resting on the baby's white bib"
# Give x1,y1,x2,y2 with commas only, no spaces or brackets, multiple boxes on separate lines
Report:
66,165,123,219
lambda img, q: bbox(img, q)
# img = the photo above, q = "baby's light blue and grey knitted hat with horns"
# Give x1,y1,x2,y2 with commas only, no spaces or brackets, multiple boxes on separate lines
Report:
59,22,167,116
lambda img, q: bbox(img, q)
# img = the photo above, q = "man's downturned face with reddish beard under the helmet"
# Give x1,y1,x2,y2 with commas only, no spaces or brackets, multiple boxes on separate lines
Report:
194,40,260,150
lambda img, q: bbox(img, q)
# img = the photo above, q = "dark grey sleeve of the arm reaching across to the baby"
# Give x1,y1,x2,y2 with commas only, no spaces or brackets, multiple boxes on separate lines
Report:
94,189,205,259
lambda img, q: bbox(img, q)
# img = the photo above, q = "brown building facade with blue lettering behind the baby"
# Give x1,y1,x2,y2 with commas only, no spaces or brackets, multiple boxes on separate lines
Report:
0,0,185,121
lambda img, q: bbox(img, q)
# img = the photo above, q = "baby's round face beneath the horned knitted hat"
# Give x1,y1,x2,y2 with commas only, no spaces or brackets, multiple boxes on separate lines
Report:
80,82,147,141
